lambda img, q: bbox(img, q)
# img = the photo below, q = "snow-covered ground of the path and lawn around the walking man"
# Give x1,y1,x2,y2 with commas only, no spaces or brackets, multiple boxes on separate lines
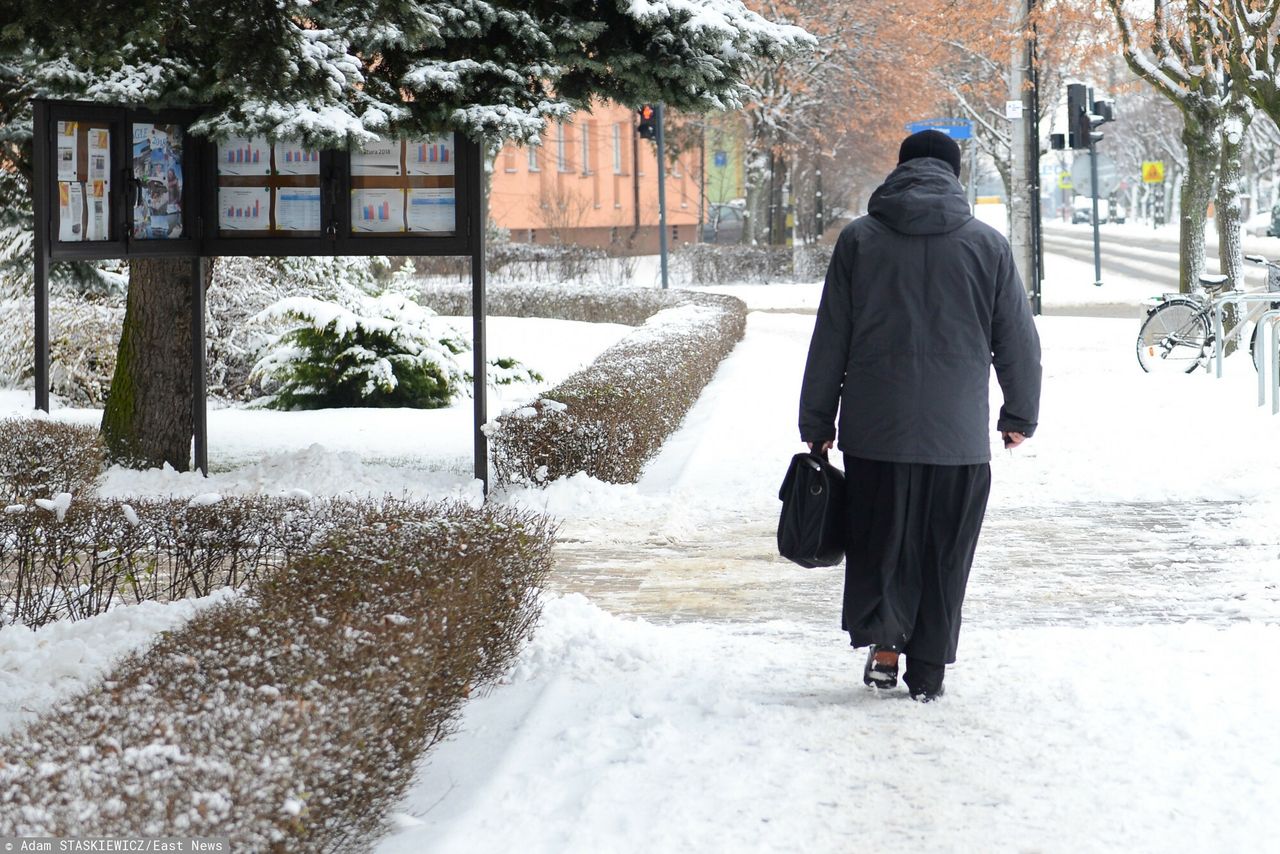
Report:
0,260,1280,854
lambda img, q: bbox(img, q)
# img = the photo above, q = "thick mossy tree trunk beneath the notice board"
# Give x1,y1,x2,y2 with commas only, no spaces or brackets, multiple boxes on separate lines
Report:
102,259,209,471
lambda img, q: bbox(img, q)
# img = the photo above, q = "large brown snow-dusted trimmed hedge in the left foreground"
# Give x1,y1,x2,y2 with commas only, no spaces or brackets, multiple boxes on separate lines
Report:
0,503,554,853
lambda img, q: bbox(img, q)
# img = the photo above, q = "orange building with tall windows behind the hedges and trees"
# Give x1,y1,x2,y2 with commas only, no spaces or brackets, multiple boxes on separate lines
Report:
489,104,701,252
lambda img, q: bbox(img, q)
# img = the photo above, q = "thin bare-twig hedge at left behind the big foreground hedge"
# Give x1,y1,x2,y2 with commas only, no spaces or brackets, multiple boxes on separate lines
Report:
0,493,450,629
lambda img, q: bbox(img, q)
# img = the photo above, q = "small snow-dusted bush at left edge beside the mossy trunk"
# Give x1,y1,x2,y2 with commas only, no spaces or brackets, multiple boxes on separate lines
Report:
0,417,106,504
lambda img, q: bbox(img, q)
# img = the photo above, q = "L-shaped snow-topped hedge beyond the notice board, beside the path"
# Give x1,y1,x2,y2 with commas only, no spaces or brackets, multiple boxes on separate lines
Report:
424,287,746,483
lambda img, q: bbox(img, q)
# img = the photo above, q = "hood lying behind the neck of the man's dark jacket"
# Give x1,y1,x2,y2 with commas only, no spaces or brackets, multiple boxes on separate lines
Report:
867,157,973,234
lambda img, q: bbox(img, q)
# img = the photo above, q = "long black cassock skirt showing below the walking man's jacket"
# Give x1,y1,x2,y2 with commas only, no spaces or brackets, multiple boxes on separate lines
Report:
841,455,991,665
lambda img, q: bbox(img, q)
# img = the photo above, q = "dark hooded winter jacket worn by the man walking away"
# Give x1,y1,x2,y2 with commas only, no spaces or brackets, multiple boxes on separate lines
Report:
800,157,1041,465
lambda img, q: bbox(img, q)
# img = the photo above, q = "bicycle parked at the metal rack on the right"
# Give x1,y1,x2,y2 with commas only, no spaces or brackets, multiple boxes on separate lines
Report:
1138,255,1280,374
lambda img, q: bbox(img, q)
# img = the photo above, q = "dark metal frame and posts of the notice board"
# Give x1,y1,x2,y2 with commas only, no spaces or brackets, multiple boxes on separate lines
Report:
32,99,489,493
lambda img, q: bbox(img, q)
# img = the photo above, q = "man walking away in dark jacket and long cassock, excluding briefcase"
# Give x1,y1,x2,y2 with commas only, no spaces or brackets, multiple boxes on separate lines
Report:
800,131,1041,702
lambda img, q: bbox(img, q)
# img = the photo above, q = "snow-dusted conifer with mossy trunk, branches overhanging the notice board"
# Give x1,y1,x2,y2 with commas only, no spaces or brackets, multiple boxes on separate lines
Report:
0,0,812,469
